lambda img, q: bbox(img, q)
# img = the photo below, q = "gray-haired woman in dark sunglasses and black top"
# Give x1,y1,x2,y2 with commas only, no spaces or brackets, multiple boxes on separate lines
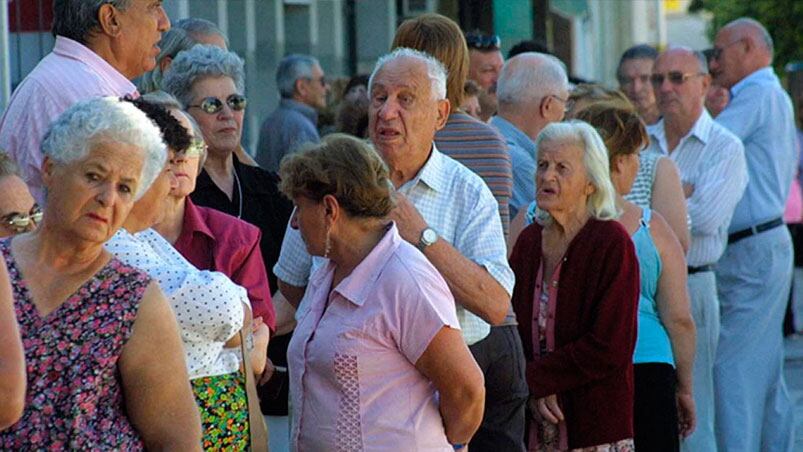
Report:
162,45,292,292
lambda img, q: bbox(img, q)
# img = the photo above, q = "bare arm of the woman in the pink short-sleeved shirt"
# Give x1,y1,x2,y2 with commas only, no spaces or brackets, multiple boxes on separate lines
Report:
415,326,485,444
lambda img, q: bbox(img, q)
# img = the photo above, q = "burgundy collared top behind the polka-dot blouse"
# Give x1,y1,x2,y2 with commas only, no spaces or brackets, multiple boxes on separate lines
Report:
173,196,276,331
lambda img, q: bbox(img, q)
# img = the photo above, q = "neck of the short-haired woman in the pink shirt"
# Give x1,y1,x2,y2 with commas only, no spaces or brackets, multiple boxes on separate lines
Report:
329,219,387,280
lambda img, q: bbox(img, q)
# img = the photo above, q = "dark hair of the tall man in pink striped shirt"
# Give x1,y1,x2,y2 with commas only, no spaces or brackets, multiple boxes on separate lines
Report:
52,0,132,44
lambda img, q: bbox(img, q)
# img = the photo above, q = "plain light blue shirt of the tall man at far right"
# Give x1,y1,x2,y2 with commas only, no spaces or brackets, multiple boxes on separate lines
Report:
716,67,797,233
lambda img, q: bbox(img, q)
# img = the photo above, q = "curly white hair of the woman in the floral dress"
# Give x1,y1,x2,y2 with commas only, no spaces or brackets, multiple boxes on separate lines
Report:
42,97,167,199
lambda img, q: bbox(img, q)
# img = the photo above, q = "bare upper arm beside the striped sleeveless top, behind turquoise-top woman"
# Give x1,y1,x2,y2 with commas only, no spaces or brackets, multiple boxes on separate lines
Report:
650,158,691,255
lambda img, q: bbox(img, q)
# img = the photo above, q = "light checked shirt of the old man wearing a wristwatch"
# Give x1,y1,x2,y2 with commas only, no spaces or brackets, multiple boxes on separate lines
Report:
273,145,515,345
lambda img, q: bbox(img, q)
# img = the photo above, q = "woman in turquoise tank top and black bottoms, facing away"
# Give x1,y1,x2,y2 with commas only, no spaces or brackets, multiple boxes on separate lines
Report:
577,104,695,451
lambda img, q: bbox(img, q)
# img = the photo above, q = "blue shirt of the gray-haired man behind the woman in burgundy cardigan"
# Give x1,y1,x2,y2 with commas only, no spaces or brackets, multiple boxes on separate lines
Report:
491,116,535,219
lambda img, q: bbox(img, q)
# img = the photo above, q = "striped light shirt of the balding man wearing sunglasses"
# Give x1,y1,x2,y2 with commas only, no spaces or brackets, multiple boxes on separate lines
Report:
647,109,747,266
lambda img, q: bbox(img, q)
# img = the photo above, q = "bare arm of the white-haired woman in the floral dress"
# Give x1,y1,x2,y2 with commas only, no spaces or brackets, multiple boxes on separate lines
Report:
118,282,206,451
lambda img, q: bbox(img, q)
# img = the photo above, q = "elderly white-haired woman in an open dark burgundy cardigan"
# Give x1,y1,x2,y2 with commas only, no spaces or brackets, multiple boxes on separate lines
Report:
510,121,639,451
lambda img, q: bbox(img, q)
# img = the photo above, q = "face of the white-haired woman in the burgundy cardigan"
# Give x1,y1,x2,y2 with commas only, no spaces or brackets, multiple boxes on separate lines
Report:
535,141,594,215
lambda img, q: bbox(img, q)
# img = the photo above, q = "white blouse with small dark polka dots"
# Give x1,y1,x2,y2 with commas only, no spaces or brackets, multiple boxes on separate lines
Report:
106,228,250,379
